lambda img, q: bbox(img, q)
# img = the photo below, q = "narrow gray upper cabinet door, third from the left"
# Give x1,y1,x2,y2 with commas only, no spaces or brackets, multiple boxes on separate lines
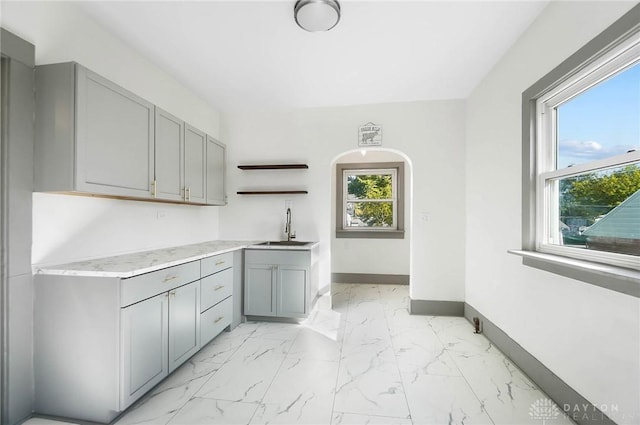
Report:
184,124,207,204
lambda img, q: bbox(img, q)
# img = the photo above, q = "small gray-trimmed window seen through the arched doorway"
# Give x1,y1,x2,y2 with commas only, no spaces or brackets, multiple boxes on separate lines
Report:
336,163,404,238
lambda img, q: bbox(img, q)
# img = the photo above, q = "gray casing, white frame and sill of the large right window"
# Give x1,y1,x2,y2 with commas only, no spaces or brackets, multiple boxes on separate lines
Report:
509,5,640,298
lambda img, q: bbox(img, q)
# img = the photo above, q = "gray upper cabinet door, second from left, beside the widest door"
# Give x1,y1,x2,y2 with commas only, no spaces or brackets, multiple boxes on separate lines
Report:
155,107,184,201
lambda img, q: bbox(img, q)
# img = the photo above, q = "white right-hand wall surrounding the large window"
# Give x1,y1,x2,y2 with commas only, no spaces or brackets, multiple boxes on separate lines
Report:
466,2,640,424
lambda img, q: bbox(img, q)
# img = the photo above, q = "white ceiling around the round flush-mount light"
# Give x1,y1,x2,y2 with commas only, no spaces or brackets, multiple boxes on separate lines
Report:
79,0,548,111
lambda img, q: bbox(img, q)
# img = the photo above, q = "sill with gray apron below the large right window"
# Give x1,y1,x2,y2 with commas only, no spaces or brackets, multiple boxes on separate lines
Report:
507,249,640,298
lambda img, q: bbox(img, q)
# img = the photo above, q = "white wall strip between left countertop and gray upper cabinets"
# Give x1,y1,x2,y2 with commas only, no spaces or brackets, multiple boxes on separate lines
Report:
32,193,218,265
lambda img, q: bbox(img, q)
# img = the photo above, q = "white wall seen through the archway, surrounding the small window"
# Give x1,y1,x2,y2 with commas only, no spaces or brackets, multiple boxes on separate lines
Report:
330,148,412,275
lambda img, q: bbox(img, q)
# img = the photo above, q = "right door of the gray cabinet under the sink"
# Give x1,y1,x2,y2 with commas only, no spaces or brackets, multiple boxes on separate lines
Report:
276,265,309,318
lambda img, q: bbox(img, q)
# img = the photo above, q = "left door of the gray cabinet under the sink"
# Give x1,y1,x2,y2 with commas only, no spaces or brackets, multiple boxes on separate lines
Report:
244,264,276,316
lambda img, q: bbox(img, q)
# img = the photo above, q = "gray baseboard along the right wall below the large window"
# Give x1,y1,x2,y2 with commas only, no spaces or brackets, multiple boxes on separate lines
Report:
464,303,615,425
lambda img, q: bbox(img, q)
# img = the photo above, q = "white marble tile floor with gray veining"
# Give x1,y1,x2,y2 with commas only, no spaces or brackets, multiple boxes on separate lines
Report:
26,284,572,425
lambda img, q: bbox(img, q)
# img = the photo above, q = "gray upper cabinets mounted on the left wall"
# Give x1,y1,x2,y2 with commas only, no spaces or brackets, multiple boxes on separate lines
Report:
35,62,226,205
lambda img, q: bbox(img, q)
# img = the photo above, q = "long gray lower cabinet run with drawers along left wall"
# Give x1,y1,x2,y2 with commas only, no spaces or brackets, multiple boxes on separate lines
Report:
34,252,236,423
